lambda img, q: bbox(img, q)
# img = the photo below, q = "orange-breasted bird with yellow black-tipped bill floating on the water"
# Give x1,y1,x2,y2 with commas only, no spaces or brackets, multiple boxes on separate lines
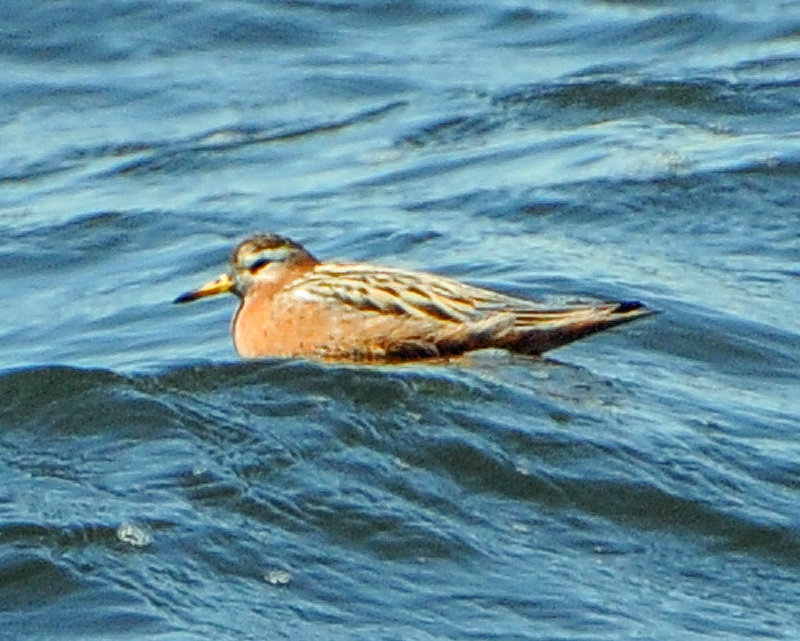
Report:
174,234,653,362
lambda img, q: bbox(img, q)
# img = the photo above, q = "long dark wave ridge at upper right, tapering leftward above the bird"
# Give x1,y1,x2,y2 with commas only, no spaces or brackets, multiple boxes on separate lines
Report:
396,72,800,159
